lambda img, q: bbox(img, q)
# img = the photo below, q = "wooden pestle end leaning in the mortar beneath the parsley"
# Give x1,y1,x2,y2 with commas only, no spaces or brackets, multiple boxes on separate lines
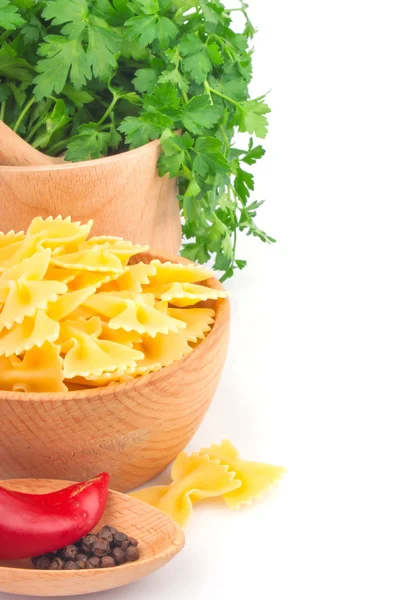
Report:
0,121,64,167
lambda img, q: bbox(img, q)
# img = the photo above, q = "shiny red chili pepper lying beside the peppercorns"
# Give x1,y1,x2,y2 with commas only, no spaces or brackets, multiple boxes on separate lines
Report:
0,473,110,560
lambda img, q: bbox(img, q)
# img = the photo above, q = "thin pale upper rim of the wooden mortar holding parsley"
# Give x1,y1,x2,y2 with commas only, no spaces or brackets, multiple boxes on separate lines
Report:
0,139,161,176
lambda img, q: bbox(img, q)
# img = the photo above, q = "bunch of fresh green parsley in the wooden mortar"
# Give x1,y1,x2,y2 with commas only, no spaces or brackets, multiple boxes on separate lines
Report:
0,0,274,278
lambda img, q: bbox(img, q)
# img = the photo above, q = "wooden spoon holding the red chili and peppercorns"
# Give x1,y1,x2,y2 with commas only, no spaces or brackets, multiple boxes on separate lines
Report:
0,479,185,596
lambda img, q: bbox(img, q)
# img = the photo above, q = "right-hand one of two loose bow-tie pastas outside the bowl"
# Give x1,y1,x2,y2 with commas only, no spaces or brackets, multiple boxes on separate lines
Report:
200,440,285,509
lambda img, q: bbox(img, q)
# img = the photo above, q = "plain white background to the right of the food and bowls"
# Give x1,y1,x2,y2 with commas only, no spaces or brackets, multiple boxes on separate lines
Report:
0,0,400,600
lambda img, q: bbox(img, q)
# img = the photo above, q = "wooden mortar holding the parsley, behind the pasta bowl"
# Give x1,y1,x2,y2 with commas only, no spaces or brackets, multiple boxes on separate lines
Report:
0,140,182,254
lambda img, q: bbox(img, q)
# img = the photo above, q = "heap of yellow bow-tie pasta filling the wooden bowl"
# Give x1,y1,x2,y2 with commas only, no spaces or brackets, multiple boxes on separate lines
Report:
0,217,226,392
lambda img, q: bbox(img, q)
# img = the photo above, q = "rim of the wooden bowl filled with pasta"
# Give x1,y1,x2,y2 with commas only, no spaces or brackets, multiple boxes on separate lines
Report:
0,250,230,406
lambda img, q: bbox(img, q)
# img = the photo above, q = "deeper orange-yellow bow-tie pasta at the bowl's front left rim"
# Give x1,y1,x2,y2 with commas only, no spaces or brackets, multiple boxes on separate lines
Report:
0,342,68,392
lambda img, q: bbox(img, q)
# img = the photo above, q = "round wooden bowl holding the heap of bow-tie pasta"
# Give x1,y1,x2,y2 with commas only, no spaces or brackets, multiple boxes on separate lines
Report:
0,254,230,491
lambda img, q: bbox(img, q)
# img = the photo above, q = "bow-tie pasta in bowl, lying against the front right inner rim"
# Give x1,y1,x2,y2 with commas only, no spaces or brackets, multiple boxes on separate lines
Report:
135,332,192,375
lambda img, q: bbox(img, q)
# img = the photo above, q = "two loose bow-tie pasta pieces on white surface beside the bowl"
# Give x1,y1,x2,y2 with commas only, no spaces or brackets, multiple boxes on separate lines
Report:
130,440,285,526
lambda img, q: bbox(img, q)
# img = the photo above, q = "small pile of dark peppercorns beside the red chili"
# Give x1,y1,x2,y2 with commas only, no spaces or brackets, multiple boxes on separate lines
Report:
32,525,139,571
